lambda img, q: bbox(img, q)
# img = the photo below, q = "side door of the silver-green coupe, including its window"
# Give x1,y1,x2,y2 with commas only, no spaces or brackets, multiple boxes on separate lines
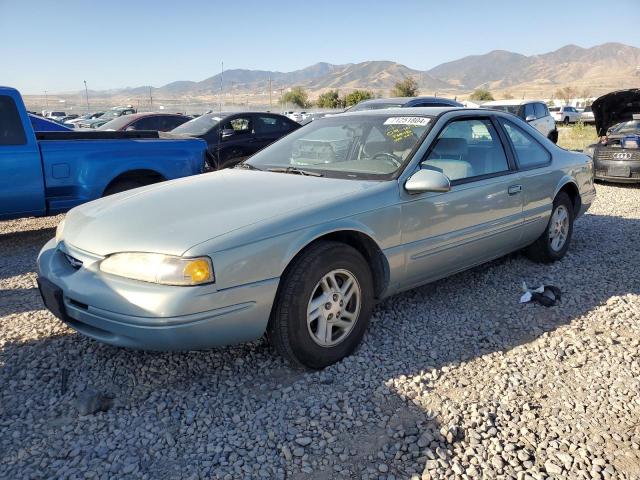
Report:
401,115,523,288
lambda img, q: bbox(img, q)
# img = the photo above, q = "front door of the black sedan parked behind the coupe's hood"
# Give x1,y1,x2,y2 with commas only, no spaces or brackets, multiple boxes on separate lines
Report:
217,114,258,168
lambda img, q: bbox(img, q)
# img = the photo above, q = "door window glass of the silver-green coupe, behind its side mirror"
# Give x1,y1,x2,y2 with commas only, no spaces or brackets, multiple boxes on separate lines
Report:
422,119,509,181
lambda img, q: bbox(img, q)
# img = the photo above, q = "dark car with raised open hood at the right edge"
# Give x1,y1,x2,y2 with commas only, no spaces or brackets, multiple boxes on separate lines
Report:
585,88,640,183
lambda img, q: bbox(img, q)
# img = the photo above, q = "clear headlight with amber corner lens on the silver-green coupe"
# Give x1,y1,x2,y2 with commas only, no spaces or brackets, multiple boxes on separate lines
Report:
100,253,215,285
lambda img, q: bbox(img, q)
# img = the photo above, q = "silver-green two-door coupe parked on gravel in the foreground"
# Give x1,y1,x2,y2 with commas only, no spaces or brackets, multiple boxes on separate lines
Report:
38,108,595,368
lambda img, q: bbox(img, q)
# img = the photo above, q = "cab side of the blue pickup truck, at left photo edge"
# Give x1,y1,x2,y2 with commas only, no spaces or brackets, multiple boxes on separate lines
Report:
0,95,45,219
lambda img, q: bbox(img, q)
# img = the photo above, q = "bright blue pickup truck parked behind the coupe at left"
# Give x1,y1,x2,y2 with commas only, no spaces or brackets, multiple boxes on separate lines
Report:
0,86,207,220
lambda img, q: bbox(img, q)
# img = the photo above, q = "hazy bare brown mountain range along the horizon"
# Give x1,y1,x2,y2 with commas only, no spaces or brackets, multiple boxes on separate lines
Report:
43,43,640,105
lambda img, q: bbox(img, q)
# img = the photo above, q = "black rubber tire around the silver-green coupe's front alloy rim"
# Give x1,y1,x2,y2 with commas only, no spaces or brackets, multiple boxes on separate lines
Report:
267,241,374,369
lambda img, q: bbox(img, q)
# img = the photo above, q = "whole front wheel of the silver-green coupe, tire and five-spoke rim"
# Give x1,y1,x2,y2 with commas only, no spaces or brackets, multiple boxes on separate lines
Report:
267,242,373,369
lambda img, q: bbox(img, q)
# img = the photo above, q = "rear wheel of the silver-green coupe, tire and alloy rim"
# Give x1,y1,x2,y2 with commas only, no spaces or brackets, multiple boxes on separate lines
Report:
525,192,574,263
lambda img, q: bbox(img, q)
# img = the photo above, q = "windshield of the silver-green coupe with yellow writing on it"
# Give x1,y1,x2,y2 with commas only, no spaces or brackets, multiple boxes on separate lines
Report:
245,115,431,179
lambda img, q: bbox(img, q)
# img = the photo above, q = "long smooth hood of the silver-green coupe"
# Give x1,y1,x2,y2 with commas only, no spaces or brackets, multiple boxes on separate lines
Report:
63,169,378,256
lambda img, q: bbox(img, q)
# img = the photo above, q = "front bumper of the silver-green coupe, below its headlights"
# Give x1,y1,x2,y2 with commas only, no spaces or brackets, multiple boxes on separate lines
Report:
38,240,278,350
